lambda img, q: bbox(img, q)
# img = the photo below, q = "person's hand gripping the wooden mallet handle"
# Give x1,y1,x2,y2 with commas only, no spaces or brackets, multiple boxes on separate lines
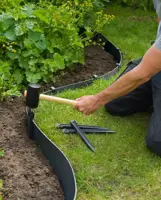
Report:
74,95,102,115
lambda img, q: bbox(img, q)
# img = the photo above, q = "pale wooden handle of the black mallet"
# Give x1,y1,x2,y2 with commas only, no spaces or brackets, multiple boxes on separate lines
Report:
24,91,76,106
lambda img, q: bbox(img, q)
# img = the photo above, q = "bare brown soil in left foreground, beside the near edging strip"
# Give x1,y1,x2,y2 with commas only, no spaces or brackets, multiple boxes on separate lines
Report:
0,98,64,200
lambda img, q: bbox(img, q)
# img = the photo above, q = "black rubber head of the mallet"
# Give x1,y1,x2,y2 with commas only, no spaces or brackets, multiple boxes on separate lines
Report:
26,83,41,108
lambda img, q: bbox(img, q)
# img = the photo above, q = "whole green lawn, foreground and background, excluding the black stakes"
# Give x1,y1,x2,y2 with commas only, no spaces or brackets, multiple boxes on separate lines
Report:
35,6,161,200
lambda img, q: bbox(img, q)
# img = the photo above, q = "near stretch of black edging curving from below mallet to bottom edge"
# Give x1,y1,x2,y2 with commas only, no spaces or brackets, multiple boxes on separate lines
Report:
26,108,77,200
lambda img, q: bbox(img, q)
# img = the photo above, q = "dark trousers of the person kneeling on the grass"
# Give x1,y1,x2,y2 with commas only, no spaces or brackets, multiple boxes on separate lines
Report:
105,59,161,156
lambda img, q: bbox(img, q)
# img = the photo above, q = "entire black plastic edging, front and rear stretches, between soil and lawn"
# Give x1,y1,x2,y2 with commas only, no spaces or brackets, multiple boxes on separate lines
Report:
26,33,122,200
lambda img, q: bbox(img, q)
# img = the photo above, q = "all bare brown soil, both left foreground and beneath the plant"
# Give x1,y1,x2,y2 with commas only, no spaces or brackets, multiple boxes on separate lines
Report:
0,46,116,200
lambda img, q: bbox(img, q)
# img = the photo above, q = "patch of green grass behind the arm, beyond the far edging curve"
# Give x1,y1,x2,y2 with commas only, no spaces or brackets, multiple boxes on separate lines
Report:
102,6,157,63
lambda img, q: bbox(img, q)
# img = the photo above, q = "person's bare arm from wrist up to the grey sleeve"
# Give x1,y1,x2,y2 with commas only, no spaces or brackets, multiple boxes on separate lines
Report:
96,46,161,105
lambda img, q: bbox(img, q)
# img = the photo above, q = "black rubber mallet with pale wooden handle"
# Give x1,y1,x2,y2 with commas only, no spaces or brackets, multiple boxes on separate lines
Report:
24,83,76,108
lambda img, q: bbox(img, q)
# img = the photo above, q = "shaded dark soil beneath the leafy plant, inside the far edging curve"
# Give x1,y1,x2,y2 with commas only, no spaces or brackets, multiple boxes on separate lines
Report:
46,45,116,87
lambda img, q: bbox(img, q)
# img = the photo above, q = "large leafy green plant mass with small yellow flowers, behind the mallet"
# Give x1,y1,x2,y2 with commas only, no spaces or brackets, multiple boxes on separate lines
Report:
0,0,113,84
